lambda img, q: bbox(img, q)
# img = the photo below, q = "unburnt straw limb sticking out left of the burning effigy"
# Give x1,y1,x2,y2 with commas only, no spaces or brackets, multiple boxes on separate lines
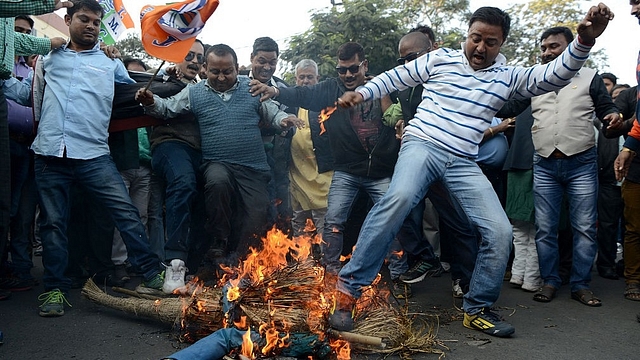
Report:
82,279,182,324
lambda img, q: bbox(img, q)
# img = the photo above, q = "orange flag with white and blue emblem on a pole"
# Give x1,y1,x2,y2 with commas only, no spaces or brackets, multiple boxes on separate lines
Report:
140,0,218,63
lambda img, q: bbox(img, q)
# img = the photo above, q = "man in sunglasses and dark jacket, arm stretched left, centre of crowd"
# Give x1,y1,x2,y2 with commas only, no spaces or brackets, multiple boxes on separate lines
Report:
252,42,424,296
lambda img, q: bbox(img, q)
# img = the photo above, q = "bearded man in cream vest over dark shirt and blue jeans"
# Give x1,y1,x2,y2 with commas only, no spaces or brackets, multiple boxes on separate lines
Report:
501,26,619,306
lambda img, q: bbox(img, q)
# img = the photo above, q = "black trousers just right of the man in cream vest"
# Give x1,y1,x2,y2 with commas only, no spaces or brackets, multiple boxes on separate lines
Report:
596,182,624,271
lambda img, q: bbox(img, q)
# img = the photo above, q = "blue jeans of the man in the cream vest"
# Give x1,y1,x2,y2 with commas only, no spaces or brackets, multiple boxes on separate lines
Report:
533,146,598,291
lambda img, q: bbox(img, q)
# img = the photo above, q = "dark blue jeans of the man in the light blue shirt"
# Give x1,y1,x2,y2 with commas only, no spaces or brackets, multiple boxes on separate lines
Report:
35,155,160,292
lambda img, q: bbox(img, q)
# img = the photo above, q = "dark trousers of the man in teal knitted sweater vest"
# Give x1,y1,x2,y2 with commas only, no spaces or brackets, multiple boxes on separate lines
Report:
202,161,270,256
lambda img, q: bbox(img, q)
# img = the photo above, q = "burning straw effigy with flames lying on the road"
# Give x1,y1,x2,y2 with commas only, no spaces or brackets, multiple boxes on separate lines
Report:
82,229,446,359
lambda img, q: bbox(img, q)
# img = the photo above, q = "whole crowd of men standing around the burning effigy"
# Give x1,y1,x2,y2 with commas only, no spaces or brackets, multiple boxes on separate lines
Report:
0,0,640,346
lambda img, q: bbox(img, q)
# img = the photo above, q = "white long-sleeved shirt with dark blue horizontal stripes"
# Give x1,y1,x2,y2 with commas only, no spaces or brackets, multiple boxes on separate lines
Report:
357,38,591,158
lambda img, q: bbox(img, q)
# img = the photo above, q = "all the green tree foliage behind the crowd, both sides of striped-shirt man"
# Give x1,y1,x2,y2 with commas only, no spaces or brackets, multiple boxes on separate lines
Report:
281,0,607,80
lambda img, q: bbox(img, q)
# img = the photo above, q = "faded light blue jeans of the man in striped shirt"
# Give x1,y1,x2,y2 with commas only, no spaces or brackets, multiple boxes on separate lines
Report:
338,136,512,314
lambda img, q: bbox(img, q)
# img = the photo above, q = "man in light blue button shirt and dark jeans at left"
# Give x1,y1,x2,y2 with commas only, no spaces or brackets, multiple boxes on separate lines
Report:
32,0,163,316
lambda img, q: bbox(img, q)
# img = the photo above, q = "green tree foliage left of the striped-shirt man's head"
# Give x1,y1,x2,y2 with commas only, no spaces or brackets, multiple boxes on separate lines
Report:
281,0,469,79
